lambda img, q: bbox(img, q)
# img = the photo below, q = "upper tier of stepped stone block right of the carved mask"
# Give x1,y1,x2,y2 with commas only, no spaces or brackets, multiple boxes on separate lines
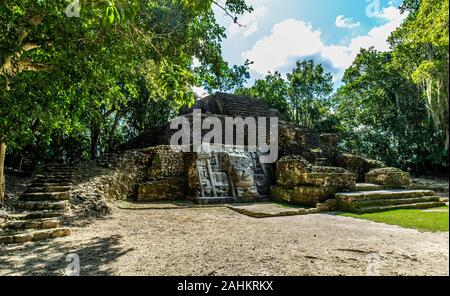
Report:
277,156,356,190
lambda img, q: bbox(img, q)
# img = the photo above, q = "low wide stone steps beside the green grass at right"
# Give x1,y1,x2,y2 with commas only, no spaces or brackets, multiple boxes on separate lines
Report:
335,184,445,213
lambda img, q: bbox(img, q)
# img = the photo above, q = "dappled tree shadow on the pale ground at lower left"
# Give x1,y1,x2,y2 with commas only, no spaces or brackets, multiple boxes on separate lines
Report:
0,235,133,275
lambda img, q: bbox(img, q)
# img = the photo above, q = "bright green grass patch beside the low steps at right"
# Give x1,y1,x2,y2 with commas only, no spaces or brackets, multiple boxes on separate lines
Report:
341,206,449,232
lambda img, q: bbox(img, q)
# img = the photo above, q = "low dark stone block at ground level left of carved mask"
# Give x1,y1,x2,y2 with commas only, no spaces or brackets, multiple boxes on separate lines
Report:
137,177,184,201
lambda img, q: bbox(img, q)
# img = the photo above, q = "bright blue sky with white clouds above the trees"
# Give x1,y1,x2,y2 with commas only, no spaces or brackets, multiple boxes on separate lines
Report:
207,0,406,91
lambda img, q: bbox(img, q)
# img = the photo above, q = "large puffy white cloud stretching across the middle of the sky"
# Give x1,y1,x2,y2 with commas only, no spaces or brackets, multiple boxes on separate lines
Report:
242,6,406,75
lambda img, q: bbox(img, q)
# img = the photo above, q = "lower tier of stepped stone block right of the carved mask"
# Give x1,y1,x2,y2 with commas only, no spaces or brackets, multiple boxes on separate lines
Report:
272,186,336,207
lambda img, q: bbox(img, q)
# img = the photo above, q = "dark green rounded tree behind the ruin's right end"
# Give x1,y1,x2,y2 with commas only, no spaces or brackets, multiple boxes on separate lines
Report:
333,49,448,173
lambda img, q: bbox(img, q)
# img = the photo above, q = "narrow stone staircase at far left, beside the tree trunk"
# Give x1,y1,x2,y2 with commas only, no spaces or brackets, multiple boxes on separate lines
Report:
0,164,77,244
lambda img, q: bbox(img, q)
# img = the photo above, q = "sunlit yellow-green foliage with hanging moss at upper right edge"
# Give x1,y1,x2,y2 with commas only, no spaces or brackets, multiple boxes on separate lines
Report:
389,0,450,149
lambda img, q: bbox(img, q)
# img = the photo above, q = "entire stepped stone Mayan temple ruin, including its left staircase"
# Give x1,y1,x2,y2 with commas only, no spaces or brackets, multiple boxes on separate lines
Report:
0,93,445,243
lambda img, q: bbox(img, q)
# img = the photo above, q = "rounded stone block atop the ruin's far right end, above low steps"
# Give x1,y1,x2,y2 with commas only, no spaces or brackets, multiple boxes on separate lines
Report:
366,168,411,187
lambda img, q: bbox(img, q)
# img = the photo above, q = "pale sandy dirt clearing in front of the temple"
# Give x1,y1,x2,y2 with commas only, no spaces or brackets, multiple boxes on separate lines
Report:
0,208,449,275
